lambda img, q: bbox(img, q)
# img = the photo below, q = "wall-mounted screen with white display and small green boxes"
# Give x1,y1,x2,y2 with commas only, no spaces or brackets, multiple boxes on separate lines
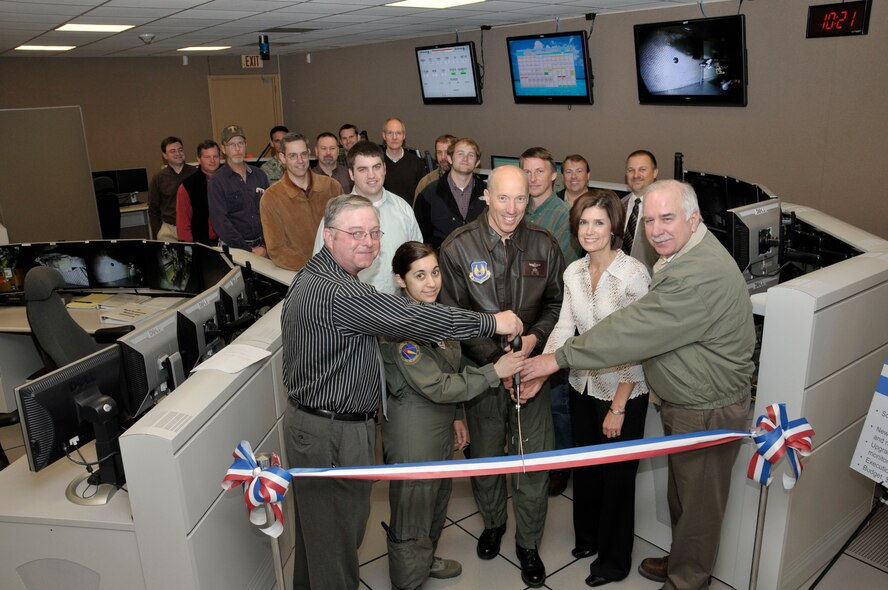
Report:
416,41,481,104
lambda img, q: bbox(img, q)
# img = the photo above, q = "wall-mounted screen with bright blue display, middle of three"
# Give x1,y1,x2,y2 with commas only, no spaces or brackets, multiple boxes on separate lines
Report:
506,31,592,104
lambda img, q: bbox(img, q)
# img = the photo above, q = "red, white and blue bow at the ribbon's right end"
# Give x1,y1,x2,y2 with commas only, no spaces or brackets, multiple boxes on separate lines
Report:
746,404,814,490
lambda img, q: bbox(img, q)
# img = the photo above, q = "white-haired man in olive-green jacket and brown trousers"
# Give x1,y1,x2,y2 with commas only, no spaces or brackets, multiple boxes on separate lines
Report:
521,180,755,590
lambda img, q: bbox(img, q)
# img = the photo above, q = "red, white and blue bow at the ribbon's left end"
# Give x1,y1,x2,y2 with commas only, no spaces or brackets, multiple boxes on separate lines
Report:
222,440,293,537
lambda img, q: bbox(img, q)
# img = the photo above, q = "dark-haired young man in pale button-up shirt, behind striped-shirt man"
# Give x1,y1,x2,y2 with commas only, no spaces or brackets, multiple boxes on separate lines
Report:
314,141,422,295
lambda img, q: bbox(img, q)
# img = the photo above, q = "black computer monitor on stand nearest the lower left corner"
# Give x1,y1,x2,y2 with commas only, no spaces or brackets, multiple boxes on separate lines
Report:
15,345,127,503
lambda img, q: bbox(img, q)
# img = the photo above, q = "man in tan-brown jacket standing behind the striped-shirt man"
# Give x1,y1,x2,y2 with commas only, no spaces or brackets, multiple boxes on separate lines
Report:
259,133,343,270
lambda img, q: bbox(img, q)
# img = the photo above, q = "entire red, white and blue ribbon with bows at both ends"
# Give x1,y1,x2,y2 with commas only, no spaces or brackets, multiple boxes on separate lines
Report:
222,404,814,536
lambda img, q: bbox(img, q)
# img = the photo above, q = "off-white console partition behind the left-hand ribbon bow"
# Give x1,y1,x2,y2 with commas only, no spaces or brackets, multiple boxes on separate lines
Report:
120,305,293,590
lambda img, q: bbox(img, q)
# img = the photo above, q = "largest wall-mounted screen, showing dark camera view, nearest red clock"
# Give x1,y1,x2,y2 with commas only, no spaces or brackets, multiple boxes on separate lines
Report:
635,14,746,107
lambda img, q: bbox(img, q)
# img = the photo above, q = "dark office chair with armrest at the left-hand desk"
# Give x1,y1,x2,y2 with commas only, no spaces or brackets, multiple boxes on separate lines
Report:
25,266,134,372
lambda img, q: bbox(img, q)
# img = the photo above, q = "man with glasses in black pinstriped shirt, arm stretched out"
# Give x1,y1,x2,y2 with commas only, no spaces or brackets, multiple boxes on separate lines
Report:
281,195,522,590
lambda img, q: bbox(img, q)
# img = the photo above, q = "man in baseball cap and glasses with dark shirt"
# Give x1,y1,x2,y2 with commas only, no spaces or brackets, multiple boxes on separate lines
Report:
207,125,268,256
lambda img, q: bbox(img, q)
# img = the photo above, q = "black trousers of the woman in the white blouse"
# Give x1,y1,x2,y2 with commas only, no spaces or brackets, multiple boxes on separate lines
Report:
570,388,648,580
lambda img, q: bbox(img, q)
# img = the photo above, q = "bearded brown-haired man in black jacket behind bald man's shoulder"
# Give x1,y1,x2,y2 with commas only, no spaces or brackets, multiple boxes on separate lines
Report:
413,137,487,249
